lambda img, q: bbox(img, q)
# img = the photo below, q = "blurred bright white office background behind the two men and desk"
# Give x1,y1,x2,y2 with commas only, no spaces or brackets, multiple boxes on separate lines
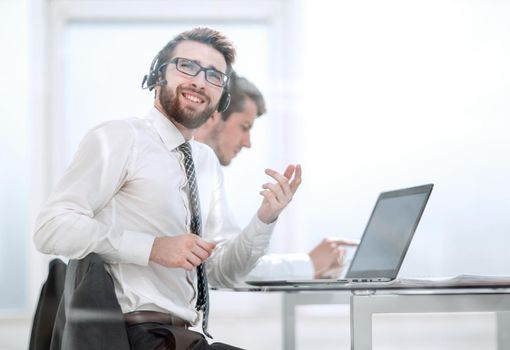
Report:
0,0,510,349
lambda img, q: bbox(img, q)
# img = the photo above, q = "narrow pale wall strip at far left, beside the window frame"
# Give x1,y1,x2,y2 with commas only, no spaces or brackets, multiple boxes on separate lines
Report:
0,0,31,313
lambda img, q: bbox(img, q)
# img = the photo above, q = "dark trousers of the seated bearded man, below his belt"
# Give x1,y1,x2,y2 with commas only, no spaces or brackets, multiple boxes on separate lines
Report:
127,323,246,350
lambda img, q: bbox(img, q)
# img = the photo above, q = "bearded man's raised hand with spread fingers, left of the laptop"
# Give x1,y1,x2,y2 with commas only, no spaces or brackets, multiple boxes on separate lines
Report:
257,164,301,224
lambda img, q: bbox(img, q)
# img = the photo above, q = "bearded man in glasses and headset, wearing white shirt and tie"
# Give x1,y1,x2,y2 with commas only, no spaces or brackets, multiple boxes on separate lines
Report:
34,28,301,349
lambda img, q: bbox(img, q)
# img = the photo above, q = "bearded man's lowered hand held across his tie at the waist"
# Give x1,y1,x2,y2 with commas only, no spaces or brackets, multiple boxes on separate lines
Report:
149,233,216,271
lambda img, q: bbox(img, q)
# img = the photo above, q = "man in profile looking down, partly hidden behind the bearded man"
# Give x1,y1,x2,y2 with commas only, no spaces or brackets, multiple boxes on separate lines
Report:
195,72,358,280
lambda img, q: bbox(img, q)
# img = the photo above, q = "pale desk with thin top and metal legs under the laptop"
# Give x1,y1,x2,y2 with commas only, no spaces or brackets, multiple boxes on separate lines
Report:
225,280,510,350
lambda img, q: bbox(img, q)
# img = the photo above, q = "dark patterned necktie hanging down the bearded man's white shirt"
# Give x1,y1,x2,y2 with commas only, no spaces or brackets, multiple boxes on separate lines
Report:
179,142,212,338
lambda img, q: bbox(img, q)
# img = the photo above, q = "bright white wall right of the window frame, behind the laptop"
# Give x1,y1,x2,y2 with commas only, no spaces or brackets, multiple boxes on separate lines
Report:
296,0,510,275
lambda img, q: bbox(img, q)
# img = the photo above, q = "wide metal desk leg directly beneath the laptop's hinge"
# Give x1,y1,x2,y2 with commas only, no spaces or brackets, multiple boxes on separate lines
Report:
351,295,372,350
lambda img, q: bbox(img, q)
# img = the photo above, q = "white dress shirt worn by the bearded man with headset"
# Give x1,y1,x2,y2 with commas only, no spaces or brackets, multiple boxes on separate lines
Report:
34,108,274,323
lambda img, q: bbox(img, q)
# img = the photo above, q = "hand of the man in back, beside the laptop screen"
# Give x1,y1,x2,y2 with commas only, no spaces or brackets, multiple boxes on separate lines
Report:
308,237,359,278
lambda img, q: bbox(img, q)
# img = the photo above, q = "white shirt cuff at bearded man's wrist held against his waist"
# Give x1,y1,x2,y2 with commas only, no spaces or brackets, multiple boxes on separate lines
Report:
119,231,156,266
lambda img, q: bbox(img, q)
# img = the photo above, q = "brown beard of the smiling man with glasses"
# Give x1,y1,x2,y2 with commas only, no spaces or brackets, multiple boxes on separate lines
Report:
159,86,217,129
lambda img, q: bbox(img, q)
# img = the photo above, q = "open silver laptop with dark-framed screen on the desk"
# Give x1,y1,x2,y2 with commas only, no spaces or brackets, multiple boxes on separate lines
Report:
246,184,434,286
